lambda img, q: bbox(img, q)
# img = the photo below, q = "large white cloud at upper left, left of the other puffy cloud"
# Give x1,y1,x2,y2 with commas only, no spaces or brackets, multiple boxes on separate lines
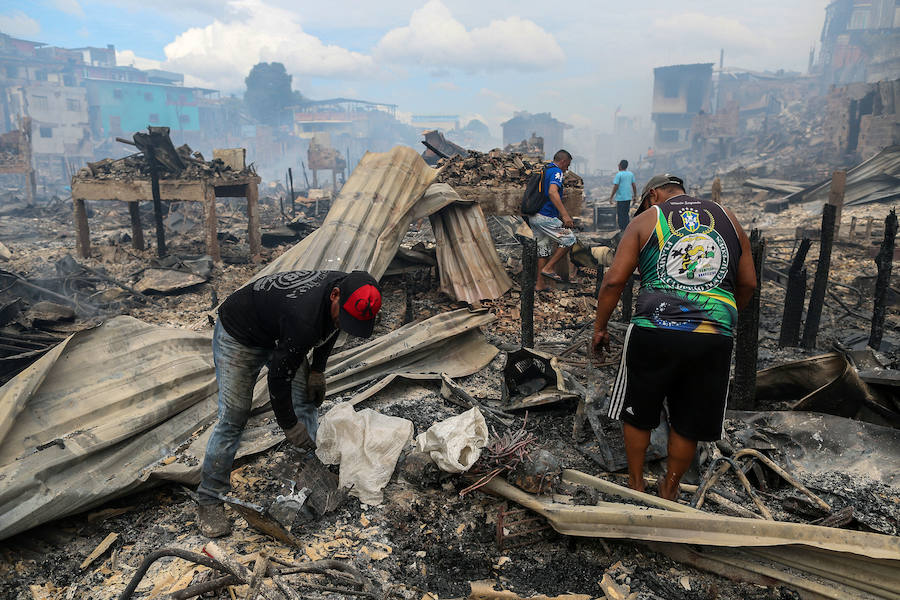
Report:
163,0,375,91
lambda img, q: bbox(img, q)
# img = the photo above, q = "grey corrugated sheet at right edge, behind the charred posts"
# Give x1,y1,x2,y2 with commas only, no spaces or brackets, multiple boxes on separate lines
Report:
787,146,900,206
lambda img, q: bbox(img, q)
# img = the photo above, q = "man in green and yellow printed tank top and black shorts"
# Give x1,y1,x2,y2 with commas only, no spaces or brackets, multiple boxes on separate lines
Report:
594,174,756,500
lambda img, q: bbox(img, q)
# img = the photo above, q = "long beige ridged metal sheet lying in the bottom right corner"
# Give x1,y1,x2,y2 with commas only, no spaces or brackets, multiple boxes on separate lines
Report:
483,469,900,599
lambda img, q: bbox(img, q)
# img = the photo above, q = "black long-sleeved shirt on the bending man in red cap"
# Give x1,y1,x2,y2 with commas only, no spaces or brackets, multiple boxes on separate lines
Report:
219,271,347,429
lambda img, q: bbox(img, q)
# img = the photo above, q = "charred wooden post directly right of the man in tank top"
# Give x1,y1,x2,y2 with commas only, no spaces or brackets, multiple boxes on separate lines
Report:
728,229,766,410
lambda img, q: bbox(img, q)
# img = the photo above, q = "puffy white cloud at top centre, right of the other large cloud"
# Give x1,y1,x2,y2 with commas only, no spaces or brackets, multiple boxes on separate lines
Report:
374,0,565,72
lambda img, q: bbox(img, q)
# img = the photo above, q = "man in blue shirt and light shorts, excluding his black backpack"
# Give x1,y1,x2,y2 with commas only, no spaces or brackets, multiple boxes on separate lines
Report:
528,150,575,291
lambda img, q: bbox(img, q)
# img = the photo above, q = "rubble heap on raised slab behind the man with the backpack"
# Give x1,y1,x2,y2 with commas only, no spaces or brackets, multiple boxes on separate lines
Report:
436,148,584,188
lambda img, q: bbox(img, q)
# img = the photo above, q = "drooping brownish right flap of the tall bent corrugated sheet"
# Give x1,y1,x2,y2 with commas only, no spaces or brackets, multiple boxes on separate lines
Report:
431,203,512,304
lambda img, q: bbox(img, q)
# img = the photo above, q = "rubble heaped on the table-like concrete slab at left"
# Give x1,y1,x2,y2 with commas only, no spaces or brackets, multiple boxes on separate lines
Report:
75,144,255,181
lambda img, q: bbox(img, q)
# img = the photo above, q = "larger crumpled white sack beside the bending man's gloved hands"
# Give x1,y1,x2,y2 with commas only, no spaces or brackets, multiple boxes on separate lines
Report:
316,402,413,505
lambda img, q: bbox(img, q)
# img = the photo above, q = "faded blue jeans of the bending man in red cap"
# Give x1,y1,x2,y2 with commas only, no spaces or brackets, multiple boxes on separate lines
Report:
197,320,319,504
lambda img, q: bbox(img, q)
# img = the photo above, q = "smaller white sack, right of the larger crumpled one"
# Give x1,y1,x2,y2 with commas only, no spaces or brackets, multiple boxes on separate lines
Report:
416,408,488,473
